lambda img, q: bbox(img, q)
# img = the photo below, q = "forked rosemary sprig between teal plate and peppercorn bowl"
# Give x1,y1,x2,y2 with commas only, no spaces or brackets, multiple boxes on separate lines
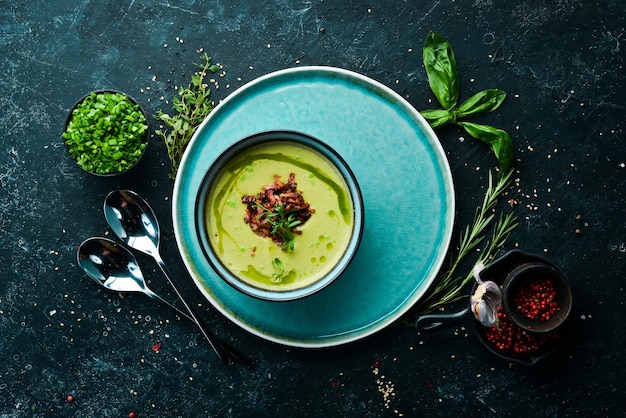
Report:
417,169,518,313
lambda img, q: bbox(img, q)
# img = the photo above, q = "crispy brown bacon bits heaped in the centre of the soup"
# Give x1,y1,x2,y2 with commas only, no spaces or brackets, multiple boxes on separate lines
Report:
241,173,315,246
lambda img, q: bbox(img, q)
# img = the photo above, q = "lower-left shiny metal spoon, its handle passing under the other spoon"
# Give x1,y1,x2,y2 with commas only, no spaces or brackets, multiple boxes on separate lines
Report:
77,237,195,323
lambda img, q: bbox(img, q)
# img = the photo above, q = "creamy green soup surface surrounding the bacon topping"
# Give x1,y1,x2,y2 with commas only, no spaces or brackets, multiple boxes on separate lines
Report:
205,141,354,291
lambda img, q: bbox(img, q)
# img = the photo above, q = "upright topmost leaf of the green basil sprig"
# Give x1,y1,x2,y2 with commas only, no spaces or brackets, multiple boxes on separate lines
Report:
423,32,459,109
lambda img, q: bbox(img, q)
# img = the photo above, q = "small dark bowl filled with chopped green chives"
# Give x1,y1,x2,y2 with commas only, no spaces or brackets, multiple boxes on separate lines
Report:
62,90,149,177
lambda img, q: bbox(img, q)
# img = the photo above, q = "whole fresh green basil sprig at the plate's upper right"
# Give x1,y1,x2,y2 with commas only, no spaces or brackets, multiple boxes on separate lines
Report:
420,32,513,176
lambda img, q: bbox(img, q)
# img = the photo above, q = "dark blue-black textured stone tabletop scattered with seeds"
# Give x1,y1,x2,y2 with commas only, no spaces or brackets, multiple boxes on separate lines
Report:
0,0,626,417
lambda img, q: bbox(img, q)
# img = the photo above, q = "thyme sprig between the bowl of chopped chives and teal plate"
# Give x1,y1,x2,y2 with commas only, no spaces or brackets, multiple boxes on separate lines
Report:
154,53,220,179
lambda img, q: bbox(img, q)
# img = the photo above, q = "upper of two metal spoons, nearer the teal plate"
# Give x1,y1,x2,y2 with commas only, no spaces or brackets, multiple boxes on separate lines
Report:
104,190,250,365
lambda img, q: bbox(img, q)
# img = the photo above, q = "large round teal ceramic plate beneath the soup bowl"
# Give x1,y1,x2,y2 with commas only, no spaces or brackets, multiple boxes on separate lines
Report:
172,67,454,348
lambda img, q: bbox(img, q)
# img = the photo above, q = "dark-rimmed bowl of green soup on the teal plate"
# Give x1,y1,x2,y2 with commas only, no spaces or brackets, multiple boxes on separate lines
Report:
196,131,364,302
